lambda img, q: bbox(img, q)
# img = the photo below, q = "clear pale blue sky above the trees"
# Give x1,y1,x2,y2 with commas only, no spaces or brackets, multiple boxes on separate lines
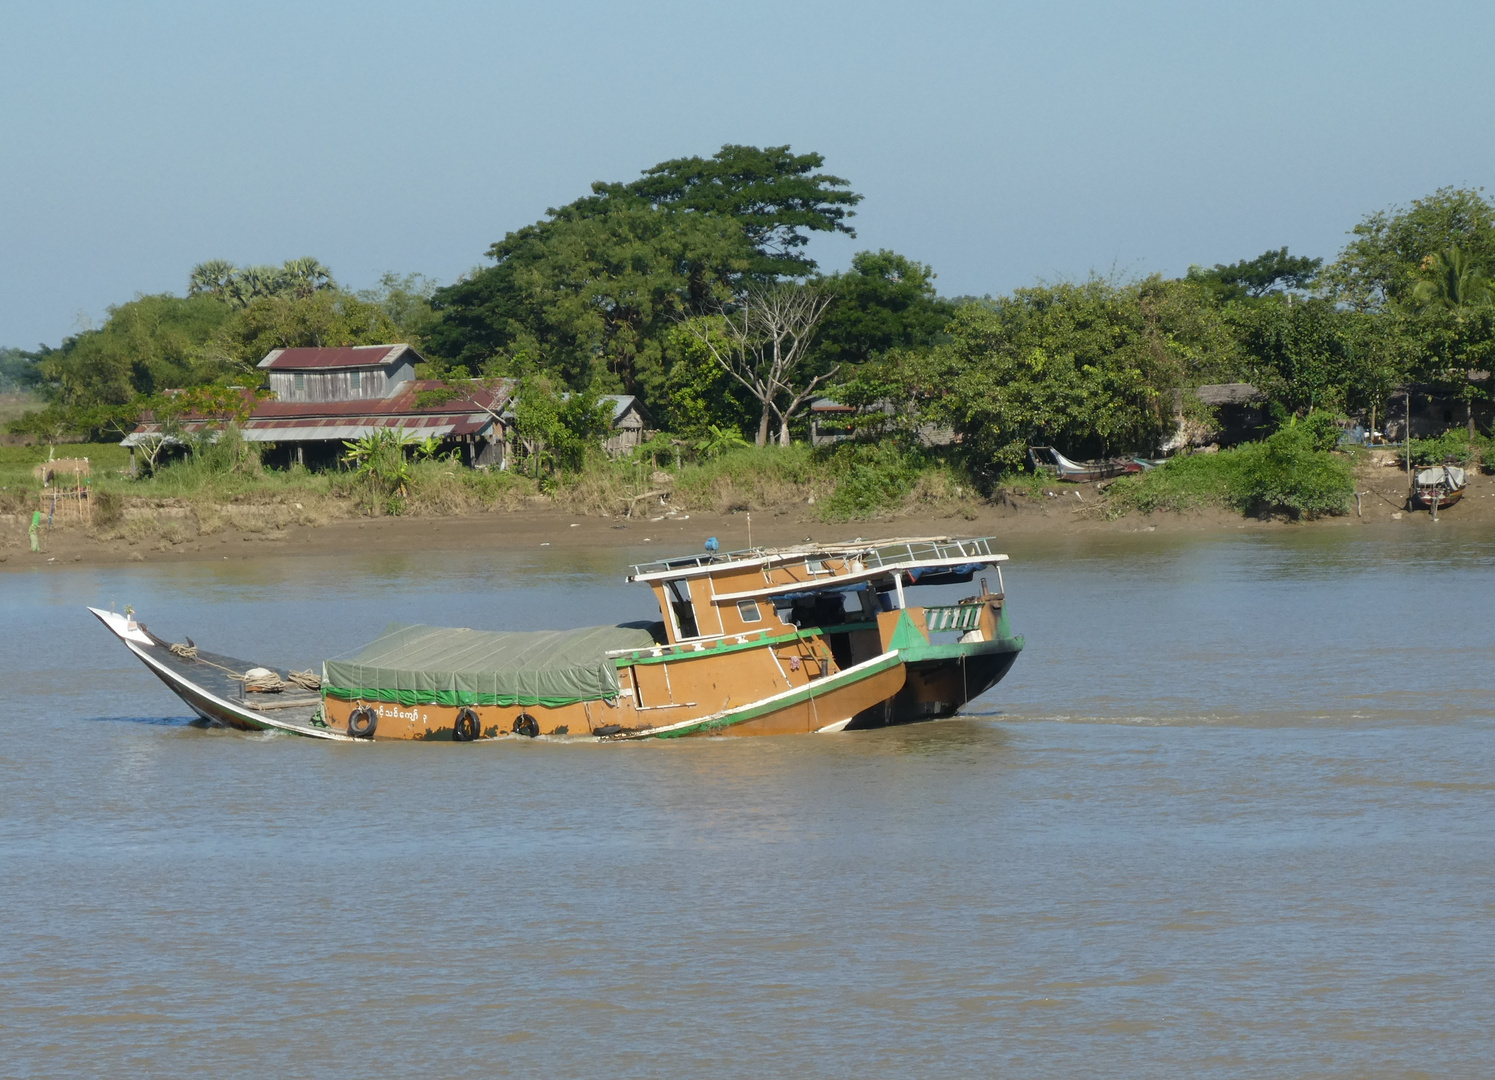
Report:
0,0,1495,347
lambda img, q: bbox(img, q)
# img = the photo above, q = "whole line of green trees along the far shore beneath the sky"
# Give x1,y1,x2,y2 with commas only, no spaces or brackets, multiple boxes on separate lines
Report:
0,145,1495,474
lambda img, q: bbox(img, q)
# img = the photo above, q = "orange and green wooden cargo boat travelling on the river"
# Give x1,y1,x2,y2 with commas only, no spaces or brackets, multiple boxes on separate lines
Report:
88,537,1024,742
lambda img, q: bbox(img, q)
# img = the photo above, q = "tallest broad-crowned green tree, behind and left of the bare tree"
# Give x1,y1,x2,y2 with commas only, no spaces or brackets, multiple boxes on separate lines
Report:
426,145,861,401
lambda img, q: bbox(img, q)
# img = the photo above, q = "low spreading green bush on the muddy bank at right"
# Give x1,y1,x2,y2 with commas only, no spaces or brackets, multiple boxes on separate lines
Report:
1106,422,1354,518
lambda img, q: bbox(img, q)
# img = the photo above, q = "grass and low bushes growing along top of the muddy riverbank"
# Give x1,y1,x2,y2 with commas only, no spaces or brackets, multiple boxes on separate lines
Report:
0,425,1417,539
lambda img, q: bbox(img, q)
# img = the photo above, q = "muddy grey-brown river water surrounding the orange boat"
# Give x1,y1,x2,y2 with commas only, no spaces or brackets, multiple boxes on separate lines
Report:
0,525,1495,1079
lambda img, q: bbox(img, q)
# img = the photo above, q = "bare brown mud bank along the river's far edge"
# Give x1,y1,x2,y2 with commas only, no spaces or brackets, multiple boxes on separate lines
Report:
0,451,1495,570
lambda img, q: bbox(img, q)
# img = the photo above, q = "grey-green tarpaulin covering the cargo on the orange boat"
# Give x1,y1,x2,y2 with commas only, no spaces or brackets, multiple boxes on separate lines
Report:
321,622,655,706
